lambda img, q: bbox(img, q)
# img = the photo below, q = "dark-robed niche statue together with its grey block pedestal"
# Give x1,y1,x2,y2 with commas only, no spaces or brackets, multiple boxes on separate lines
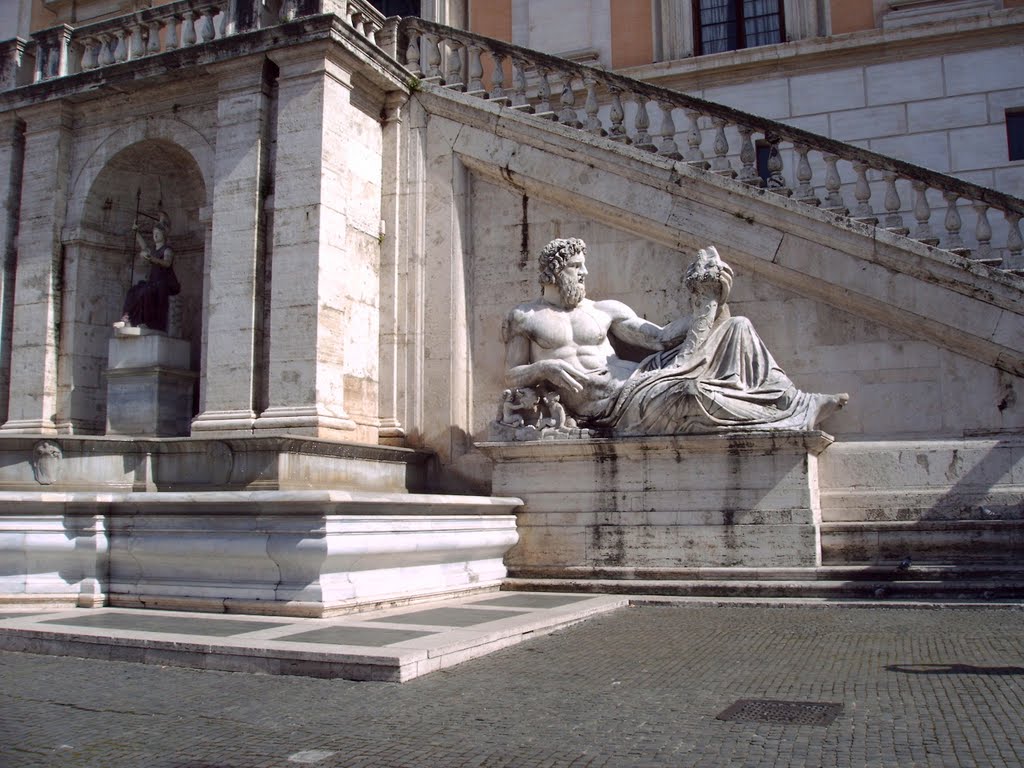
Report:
106,211,197,437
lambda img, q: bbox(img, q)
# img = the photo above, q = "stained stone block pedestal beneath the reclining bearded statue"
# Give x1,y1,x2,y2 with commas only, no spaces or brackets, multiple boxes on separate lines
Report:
479,431,833,579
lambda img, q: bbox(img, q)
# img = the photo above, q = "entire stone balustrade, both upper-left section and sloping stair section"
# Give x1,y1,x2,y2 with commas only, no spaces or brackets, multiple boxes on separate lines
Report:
6,6,1024,274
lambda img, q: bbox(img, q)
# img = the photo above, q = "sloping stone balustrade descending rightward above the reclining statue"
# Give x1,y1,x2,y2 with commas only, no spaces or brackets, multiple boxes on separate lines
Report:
398,17,1024,271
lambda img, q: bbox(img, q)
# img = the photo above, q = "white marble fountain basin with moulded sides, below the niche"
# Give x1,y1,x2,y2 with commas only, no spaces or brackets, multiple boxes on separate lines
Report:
0,490,519,616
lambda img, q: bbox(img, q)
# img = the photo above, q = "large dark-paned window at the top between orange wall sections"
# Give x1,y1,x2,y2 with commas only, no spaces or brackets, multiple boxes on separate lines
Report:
693,0,785,53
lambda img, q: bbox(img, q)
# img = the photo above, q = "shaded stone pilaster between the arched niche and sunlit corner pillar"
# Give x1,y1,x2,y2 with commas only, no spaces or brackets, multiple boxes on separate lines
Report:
191,58,269,435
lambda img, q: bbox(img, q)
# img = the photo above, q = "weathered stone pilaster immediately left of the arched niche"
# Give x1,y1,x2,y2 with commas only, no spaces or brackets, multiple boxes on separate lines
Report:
2,102,72,434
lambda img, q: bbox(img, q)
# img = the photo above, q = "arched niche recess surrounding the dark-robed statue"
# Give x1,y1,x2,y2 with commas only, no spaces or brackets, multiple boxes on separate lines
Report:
56,139,209,434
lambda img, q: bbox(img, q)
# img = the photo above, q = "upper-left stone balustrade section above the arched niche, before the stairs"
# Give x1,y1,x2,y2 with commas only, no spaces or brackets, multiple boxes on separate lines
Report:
0,0,384,90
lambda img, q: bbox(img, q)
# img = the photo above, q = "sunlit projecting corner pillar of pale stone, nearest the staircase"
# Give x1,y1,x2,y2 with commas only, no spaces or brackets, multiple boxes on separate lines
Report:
255,44,384,443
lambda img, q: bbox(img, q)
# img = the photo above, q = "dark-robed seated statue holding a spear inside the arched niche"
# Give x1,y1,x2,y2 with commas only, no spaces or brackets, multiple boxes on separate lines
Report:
114,211,181,334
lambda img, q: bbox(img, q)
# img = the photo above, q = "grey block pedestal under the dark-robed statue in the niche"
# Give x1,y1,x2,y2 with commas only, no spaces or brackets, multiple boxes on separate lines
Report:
105,329,196,437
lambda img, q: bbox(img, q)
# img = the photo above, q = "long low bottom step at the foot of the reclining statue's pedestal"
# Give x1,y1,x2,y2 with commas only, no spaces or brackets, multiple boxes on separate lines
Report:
502,569,1024,601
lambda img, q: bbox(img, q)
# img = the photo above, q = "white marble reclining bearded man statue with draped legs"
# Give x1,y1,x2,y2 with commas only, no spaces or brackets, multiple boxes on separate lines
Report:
498,238,849,439
